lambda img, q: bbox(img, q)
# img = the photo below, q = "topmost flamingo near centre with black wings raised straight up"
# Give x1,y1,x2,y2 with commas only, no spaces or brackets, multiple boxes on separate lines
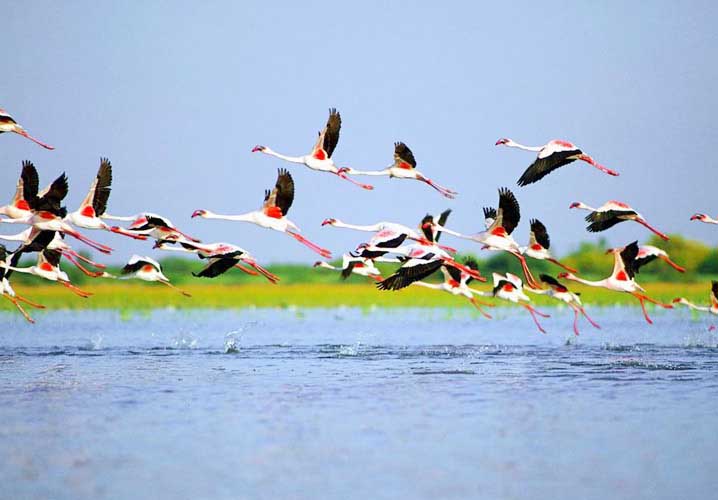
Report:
252,108,374,190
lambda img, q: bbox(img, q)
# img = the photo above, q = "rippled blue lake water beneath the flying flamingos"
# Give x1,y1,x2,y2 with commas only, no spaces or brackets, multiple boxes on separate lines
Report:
0,307,718,500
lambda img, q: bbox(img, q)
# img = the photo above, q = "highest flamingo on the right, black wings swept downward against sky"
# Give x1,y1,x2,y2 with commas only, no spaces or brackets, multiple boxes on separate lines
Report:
496,139,618,186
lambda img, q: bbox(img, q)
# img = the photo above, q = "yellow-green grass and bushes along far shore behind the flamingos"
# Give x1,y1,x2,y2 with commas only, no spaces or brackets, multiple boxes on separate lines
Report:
2,235,718,309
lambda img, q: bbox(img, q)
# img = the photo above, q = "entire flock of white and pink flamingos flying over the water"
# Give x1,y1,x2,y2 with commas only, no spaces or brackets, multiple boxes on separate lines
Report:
0,109,718,335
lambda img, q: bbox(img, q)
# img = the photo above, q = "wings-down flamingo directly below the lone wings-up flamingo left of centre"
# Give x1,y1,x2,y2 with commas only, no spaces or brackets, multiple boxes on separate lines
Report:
155,238,279,284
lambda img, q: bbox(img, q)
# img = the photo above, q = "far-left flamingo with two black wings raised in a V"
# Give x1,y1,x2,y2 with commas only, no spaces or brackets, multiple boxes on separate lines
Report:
0,170,112,254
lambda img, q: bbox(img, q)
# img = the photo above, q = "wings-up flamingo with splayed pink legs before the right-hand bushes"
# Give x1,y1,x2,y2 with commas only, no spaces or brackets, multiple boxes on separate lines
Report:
558,241,673,325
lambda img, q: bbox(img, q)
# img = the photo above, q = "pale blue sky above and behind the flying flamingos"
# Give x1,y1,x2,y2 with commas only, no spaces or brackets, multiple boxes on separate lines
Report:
0,1,718,263
